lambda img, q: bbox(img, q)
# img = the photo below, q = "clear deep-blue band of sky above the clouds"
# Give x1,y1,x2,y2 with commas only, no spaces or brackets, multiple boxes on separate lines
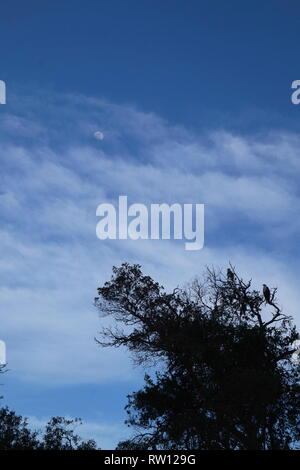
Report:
0,0,300,126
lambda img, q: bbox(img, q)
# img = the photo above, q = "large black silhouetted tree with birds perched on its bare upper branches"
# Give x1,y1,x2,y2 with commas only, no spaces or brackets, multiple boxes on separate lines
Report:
95,263,300,450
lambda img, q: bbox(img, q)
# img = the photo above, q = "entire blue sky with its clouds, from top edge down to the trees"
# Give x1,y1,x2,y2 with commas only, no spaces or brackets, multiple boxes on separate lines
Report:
0,0,300,448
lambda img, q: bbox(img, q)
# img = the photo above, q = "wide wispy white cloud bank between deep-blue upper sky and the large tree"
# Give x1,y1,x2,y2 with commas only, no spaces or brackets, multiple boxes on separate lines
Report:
0,90,300,384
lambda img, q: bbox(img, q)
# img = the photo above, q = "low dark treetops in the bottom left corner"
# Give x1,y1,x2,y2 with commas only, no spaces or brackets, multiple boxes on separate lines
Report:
0,407,96,450
